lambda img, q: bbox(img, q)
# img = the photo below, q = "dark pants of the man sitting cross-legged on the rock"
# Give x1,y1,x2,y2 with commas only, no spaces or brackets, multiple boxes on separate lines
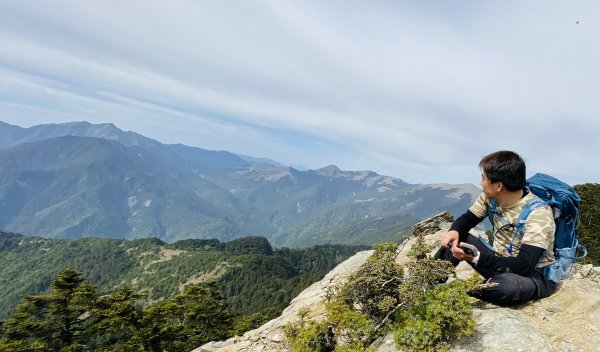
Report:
435,234,556,306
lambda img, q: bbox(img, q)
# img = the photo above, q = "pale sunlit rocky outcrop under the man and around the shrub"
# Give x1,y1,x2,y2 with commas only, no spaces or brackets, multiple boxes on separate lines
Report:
193,214,600,352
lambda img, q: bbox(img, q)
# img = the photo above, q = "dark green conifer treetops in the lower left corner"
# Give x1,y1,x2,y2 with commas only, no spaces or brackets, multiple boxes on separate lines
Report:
0,269,233,352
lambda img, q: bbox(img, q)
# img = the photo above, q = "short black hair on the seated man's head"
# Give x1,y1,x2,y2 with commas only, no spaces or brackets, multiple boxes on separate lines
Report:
479,150,526,192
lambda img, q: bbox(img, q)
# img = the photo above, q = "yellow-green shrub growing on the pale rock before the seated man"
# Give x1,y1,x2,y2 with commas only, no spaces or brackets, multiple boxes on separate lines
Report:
285,238,479,352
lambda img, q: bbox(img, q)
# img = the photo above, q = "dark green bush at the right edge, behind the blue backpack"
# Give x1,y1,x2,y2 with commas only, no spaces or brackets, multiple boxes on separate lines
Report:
574,183,600,266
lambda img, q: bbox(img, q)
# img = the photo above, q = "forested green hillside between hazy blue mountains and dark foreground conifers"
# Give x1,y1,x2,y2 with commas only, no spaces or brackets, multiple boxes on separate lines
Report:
0,232,366,329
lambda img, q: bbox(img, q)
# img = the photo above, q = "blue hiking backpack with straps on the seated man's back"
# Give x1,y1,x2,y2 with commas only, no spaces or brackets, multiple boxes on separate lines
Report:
488,173,587,282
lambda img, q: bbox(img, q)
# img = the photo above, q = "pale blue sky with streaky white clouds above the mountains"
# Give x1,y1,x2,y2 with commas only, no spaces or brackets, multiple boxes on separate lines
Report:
0,0,600,184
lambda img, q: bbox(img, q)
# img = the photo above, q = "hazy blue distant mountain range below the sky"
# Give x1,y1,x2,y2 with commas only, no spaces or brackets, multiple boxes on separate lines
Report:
0,122,479,246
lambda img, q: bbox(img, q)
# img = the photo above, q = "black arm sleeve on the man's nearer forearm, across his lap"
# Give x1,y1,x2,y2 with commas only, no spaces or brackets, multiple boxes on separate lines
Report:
477,244,544,274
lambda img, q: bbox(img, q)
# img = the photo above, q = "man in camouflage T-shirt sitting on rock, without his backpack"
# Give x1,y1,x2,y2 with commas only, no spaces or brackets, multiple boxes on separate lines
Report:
435,151,556,306
